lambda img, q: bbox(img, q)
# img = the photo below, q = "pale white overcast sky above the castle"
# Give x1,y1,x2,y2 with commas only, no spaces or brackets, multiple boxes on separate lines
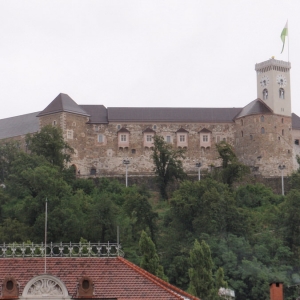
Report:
0,0,300,119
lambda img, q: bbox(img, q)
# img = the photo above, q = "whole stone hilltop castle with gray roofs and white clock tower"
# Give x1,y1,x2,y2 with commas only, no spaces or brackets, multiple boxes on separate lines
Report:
0,58,300,177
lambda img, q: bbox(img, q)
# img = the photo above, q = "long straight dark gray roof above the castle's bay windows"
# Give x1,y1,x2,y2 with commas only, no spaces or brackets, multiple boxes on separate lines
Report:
107,107,242,123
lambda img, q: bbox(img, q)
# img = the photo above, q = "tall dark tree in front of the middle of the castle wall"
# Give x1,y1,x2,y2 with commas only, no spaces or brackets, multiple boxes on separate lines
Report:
152,136,186,199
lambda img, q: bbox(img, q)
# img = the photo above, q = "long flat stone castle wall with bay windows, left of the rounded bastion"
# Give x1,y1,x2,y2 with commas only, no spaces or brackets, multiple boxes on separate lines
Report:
45,113,235,176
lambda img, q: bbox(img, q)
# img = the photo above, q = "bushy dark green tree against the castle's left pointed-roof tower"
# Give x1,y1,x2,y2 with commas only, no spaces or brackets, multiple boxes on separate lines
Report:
26,125,74,169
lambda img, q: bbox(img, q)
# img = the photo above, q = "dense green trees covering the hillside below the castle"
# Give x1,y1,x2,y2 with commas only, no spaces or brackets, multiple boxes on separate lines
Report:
0,132,300,300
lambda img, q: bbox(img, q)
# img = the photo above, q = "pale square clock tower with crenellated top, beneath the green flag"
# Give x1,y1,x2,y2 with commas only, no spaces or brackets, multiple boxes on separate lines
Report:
255,58,292,117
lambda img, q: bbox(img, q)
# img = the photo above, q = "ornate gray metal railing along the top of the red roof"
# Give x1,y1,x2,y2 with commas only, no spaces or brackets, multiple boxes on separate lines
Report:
0,242,124,258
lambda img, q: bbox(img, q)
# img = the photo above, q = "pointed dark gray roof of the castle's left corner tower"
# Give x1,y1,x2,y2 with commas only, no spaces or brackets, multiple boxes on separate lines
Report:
38,93,89,117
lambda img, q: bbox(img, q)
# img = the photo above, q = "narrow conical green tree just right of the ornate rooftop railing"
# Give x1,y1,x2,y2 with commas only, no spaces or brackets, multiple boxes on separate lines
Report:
139,231,168,281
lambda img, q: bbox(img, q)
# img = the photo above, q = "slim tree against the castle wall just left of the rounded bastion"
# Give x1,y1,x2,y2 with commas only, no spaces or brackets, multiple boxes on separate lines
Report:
216,141,249,186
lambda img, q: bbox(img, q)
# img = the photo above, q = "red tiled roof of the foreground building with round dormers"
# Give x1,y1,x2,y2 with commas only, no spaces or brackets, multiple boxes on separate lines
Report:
0,257,198,300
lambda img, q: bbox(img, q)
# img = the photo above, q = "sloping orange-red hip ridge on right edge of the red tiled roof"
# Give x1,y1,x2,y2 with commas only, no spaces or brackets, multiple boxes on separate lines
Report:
117,256,199,300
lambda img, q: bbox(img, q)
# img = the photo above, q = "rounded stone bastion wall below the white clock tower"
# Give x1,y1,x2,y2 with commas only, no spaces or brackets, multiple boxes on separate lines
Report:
235,114,293,177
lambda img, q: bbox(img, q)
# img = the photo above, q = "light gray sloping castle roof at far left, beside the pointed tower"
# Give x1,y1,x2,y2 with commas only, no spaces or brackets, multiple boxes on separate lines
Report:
0,112,39,139
